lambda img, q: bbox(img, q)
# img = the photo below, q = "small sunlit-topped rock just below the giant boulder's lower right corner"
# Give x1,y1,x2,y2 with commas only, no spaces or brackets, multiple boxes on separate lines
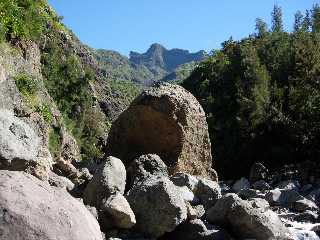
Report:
195,179,221,209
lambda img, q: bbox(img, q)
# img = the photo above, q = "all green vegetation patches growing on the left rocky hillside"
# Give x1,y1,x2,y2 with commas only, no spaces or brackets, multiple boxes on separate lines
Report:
0,0,109,161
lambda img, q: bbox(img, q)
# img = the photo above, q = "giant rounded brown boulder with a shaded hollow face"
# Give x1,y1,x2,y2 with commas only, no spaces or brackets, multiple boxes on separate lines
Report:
107,84,217,179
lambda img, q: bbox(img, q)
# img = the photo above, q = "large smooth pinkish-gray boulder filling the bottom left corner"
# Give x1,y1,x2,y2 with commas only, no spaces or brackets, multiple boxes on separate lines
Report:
0,170,102,240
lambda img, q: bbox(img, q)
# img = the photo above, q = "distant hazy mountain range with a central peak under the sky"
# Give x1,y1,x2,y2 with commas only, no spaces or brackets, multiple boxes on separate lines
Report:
94,43,207,86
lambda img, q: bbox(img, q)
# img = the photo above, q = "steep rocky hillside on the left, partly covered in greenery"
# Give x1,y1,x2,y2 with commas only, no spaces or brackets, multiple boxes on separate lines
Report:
0,0,139,174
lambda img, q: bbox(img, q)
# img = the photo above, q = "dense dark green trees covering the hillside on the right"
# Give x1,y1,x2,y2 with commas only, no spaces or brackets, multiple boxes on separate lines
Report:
183,5,320,178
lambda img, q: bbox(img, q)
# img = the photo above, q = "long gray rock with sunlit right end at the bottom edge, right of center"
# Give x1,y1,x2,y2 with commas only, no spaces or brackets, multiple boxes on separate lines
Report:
206,194,290,240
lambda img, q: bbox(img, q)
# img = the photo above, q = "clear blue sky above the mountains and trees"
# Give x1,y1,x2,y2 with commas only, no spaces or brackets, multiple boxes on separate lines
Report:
49,0,320,55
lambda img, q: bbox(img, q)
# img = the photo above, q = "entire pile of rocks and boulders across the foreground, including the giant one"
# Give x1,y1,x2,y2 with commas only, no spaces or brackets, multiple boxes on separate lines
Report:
0,85,320,240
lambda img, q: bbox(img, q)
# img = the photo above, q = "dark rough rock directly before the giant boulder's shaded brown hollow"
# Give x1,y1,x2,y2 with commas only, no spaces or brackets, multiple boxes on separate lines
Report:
127,154,168,188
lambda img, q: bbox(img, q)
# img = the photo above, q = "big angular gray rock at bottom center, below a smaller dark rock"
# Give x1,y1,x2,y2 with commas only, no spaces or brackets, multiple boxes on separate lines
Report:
127,177,187,238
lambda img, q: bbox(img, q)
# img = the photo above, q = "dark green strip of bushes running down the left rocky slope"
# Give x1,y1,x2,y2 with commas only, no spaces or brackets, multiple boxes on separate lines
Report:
41,21,108,161
